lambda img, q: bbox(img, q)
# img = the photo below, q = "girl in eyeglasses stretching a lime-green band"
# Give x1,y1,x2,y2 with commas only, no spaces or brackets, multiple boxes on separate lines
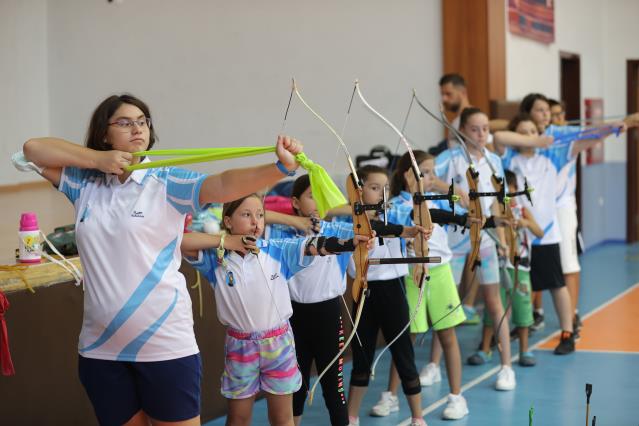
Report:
23,95,302,425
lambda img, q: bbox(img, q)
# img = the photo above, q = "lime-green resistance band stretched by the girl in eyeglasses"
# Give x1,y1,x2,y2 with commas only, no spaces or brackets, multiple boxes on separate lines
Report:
126,146,347,218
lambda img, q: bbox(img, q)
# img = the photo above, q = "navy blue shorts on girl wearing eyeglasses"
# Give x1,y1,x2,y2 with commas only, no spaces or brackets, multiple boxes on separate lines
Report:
78,354,202,426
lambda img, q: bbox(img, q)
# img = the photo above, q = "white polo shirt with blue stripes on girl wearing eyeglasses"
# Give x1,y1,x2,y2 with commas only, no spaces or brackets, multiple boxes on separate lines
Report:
59,161,206,361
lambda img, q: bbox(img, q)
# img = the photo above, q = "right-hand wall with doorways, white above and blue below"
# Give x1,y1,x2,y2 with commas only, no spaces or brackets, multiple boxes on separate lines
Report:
506,0,639,247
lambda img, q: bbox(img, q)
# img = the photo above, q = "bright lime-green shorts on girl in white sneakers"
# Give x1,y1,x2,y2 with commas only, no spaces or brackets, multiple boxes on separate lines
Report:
406,263,466,333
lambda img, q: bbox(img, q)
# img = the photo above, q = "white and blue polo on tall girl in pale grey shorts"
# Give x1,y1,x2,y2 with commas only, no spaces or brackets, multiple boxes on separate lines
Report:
435,147,504,255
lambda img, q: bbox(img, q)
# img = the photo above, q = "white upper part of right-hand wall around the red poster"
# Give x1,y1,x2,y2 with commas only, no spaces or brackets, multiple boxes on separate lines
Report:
506,0,639,162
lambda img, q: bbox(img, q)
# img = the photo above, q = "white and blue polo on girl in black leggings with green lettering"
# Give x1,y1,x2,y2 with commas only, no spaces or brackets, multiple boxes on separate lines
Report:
269,221,353,303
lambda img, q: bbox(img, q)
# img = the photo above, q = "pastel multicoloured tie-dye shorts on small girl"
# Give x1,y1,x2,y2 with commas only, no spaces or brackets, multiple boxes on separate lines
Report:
222,324,302,399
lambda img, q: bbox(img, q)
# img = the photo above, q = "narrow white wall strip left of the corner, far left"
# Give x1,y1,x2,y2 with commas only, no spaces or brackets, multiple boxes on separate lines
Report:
0,0,49,185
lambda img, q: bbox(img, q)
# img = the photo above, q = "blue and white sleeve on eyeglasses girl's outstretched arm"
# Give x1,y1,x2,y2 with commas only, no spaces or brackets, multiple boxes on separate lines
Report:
166,167,208,214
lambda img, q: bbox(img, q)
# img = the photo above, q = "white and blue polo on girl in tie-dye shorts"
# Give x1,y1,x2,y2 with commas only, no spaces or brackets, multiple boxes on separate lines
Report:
187,238,314,332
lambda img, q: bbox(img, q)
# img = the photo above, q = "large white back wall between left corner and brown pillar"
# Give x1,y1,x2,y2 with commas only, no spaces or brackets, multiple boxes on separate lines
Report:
41,0,442,179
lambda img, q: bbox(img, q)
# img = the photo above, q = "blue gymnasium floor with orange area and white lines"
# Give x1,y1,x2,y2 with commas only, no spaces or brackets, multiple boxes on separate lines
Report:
205,243,639,426
